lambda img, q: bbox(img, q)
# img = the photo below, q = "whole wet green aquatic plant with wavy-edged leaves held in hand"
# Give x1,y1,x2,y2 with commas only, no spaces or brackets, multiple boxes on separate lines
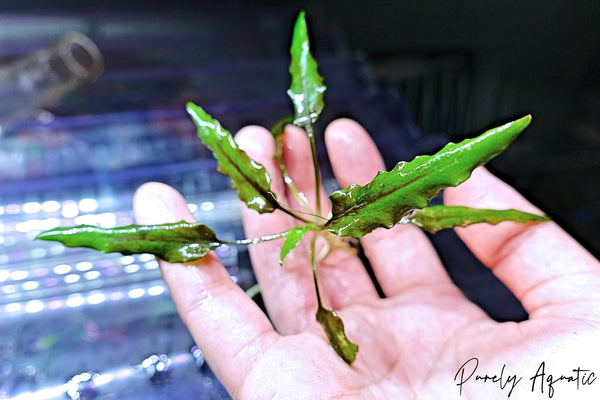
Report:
37,12,548,364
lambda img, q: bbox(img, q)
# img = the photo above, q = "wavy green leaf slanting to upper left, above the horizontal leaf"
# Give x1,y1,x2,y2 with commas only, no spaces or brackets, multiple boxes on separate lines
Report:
187,103,279,213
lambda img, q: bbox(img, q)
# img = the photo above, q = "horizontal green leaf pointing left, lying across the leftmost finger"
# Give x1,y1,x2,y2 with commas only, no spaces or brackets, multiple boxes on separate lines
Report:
36,221,222,263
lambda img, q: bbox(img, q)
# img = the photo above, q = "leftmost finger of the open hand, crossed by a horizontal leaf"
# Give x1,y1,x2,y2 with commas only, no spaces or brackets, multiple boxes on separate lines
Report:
134,183,278,393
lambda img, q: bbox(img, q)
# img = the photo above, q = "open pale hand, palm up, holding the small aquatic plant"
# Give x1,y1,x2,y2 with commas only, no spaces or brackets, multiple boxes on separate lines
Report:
134,120,600,399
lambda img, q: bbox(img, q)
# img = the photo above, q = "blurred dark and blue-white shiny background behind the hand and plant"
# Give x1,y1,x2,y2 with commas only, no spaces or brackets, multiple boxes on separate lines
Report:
0,0,600,399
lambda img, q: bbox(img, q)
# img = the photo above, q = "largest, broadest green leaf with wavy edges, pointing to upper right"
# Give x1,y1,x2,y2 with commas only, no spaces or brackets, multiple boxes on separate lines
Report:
326,115,531,237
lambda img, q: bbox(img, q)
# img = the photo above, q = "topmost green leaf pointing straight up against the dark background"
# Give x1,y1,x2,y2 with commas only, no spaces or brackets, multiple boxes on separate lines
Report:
288,11,326,125
